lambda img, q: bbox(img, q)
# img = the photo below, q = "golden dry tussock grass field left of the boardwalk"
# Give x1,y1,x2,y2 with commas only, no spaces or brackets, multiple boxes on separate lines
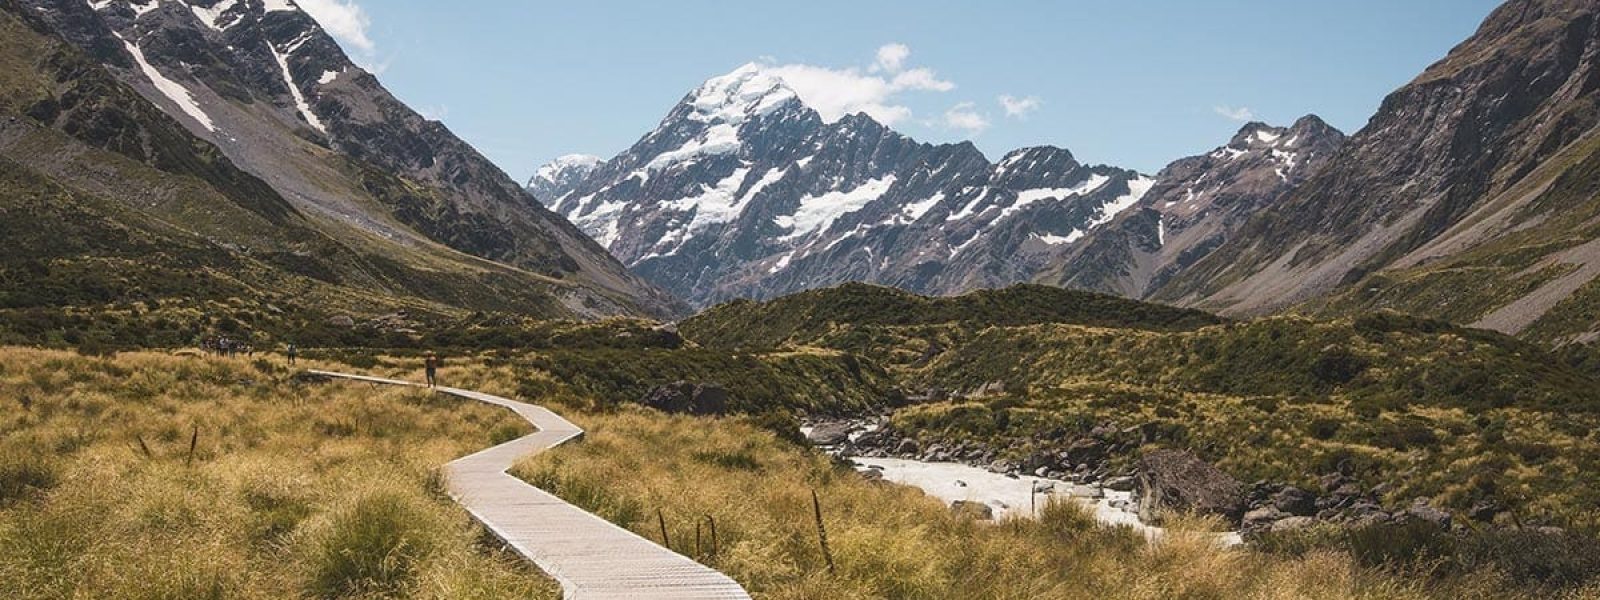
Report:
0,349,558,600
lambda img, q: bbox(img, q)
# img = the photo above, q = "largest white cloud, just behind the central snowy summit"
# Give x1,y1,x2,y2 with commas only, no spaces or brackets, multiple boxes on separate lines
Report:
763,43,955,125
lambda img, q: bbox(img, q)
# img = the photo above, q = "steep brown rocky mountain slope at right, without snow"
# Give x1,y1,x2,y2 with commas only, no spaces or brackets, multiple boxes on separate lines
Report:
1150,0,1600,347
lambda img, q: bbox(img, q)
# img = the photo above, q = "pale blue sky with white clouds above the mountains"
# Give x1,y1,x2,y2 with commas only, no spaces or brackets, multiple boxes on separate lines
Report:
298,0,1498,181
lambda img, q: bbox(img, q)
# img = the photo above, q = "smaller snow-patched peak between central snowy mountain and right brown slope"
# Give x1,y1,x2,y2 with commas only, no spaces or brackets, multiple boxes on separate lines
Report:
1037,115,1346,298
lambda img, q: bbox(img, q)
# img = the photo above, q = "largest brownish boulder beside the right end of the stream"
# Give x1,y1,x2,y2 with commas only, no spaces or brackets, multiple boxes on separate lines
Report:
1134,450,1245,523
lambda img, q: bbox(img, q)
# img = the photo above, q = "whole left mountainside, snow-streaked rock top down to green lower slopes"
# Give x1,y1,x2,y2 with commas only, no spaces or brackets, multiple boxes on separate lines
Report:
0,0,683,345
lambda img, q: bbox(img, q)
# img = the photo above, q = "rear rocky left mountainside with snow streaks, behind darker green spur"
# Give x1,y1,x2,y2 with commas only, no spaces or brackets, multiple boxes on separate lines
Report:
5,0,682,317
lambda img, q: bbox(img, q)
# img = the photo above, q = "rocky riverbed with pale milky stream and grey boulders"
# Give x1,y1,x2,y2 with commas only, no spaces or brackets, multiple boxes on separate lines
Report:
802,416,1498,542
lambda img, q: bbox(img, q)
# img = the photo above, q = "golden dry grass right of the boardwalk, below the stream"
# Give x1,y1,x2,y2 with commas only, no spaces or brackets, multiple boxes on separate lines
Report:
514,410,1587,600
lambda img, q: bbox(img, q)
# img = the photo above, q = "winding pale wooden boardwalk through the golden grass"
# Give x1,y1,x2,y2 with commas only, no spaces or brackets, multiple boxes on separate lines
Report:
310,371,750,600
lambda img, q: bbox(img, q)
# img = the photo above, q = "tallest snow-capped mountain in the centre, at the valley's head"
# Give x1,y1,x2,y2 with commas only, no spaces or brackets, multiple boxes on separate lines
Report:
547,64,1155,306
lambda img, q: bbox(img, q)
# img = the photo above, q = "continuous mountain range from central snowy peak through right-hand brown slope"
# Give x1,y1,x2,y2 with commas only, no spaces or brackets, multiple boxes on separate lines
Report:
534,0,1600,342
